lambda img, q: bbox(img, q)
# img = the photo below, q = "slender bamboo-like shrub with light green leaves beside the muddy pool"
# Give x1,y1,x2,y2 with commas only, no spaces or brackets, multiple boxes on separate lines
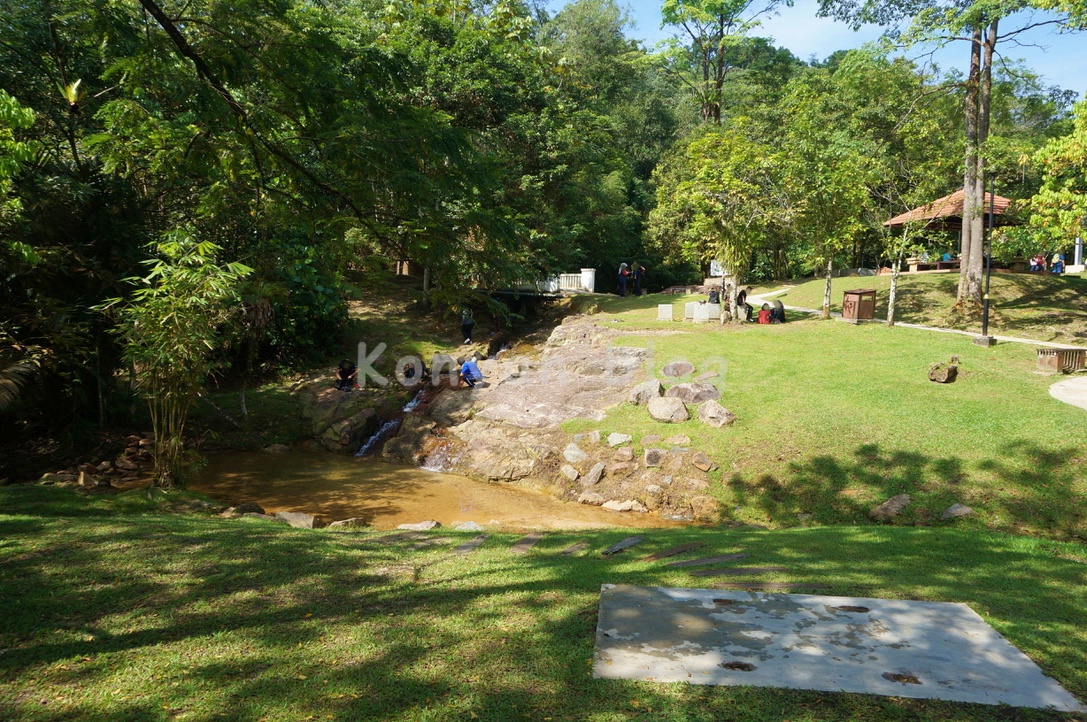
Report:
105,232,251,488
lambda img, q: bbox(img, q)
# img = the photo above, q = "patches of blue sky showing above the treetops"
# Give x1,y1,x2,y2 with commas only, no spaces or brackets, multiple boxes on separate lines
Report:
549,0,1087,98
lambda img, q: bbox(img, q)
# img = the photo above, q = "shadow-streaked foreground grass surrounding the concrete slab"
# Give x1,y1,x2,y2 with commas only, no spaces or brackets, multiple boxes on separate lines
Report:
0,487,1087,722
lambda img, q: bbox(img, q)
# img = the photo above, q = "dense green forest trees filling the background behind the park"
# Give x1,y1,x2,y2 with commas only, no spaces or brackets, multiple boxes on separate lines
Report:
0,0,1087,482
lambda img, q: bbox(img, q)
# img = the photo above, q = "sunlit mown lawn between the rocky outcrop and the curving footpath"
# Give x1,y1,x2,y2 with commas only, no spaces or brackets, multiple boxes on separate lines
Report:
566,297,1087,539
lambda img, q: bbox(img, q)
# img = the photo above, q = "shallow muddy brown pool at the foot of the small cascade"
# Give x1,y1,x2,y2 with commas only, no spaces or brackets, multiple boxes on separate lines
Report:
188,449,678,531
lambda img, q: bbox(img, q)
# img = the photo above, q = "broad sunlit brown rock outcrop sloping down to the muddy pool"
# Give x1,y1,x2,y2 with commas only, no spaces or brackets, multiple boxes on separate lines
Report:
382,318,717,521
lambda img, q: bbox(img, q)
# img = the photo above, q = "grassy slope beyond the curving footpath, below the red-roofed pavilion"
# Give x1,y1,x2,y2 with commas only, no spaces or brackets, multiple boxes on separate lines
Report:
760,273,1087,345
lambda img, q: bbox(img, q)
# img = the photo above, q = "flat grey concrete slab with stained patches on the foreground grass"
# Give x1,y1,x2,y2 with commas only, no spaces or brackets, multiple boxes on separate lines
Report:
592,584,1087,712
